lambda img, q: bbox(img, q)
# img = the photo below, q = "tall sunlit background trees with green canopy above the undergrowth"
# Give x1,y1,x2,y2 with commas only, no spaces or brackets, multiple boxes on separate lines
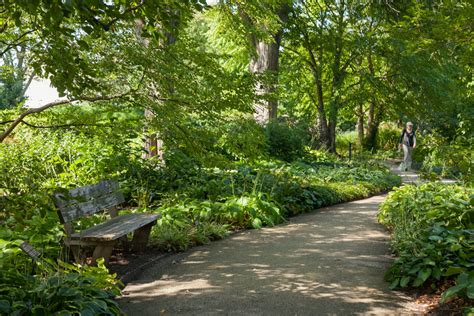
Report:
0,0,472,157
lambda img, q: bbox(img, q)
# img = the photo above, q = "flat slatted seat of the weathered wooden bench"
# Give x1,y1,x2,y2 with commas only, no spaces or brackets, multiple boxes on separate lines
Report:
70,213,160,242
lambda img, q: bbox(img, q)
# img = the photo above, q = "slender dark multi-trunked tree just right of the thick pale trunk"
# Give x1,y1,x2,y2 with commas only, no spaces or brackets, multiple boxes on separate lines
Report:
284,0,366,152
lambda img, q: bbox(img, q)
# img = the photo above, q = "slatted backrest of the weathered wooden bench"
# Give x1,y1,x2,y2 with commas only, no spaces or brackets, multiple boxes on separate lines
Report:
53,180,125,224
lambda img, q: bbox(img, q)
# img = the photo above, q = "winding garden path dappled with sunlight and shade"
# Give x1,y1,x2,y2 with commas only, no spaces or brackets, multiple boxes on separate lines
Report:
119,173,417,315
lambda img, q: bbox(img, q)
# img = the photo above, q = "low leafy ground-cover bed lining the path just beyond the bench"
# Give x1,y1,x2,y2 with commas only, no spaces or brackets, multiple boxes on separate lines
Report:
147,158,400,250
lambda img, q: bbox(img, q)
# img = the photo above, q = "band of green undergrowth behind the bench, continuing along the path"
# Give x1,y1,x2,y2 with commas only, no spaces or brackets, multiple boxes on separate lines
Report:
0,123,399,252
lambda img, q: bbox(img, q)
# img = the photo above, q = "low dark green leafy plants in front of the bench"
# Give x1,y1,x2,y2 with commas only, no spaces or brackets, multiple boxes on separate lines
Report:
0,260,120,315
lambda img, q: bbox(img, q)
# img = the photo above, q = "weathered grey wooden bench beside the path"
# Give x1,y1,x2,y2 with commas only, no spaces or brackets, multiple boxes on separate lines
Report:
54,180,160,264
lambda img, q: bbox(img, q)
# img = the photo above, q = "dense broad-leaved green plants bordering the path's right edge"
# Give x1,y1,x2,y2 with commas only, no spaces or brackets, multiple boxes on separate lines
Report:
379,182,474,313
